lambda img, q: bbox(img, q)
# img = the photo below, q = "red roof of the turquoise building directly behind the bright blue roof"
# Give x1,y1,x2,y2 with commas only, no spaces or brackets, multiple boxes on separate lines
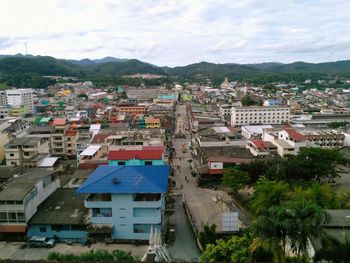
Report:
108,150,163,160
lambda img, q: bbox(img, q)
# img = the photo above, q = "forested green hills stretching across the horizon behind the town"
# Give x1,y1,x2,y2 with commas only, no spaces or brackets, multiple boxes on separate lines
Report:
0,55,350,86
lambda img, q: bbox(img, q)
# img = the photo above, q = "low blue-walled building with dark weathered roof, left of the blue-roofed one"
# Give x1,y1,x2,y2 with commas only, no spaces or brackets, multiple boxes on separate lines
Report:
27,188,88,242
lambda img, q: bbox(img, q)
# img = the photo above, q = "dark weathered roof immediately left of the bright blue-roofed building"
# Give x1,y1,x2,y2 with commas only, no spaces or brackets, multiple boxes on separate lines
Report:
29,188,88,225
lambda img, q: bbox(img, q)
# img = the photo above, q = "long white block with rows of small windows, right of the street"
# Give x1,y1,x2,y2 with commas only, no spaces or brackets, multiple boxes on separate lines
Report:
231,106,290,126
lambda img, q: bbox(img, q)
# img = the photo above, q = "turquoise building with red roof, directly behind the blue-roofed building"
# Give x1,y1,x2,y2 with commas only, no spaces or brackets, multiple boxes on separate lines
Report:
108,149,164,166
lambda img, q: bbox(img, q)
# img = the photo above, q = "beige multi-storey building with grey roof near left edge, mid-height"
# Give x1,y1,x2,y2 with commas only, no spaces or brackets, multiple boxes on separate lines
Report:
5,137,49,168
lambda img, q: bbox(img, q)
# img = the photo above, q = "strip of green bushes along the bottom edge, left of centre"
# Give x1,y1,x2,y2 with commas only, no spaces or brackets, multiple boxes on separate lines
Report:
47,249,136,262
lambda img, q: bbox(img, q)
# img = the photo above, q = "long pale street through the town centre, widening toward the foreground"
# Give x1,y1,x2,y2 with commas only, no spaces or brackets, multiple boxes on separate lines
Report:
173,105,232,231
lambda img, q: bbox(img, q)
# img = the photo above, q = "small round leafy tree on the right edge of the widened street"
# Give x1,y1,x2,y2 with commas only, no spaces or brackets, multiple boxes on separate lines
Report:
222,167,250,192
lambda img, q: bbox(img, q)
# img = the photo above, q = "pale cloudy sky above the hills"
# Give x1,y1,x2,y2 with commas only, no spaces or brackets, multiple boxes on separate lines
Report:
0,0,350,67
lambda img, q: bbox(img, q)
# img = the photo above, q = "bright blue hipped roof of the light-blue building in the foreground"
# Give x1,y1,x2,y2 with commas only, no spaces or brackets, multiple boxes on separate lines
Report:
77,165,169,194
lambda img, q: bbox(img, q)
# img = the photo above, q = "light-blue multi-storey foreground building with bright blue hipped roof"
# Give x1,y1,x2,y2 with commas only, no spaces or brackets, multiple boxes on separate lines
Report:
77,165,169,240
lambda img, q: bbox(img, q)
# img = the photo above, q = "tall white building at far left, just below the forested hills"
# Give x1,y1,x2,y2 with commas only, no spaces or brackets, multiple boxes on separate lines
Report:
6,89,34,113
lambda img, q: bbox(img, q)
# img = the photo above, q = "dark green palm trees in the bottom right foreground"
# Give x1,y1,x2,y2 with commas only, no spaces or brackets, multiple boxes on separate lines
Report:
251,201,330,262
